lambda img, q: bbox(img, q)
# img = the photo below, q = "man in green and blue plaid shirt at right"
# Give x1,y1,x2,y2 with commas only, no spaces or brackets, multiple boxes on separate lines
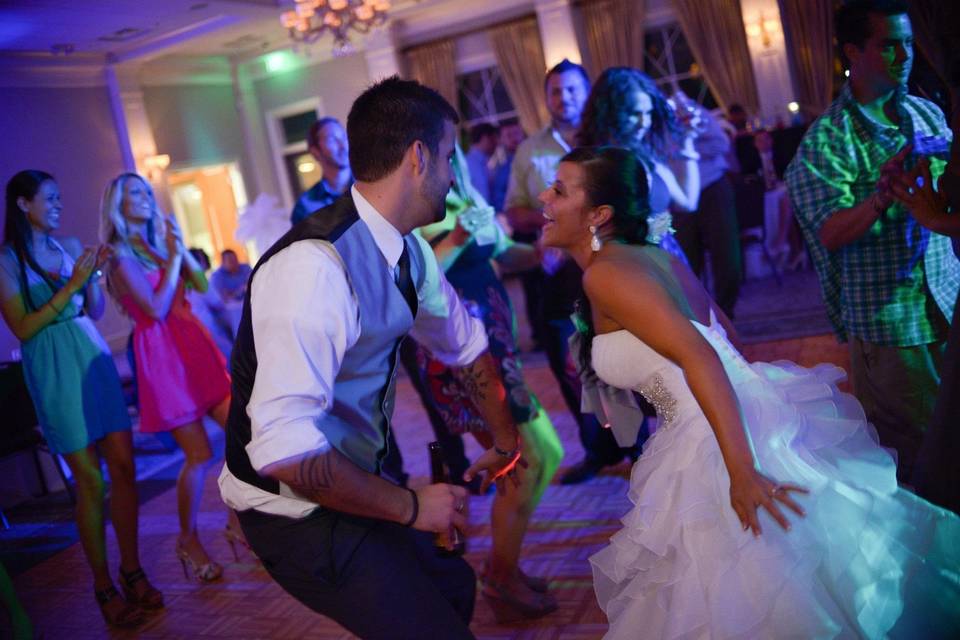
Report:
786,0,960,479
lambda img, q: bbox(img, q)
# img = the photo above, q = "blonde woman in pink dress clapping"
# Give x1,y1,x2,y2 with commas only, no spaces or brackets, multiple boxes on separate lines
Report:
100,173,230,582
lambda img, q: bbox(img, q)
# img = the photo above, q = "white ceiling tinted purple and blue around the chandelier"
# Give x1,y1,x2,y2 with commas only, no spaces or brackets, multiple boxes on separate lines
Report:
0,0,533,61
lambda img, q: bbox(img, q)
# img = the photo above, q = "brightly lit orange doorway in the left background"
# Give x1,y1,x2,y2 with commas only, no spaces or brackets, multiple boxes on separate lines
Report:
167,162,257,268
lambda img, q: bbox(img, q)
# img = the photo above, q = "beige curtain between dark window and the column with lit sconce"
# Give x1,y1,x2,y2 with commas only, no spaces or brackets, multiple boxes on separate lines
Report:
673,0,760,114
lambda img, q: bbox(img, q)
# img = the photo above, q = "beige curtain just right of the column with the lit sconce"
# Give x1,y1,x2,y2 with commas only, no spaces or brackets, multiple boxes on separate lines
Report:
779,0,833,119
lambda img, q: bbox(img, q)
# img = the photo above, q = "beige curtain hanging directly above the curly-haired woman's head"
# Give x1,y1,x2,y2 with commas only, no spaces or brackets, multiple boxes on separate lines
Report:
581,0,646,77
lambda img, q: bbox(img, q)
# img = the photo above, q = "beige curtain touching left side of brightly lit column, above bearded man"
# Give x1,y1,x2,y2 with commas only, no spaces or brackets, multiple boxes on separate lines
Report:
487,18,550,134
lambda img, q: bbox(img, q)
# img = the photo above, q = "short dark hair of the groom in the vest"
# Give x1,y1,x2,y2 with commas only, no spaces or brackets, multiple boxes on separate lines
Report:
347,76,460,182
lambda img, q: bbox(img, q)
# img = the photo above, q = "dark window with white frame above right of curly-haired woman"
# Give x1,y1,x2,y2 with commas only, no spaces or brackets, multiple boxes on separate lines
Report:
643,22,719,110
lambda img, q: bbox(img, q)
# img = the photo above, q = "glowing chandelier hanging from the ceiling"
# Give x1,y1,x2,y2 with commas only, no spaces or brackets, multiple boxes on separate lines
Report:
280,0,390,49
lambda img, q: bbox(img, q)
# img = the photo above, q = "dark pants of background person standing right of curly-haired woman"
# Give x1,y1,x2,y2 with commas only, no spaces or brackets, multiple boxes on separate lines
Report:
673,176,743,318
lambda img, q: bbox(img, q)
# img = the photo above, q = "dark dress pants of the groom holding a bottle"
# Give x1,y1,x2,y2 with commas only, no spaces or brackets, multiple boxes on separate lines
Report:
238,509,476,640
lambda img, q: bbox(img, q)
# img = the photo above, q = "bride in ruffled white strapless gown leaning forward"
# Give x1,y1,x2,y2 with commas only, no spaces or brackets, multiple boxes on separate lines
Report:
540,147,960,639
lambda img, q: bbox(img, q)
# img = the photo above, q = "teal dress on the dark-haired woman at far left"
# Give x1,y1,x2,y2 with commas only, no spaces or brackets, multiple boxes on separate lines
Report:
7,244,130,454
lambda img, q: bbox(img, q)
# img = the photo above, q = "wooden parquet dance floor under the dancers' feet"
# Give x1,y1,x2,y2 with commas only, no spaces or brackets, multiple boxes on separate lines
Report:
7,324,847,640
